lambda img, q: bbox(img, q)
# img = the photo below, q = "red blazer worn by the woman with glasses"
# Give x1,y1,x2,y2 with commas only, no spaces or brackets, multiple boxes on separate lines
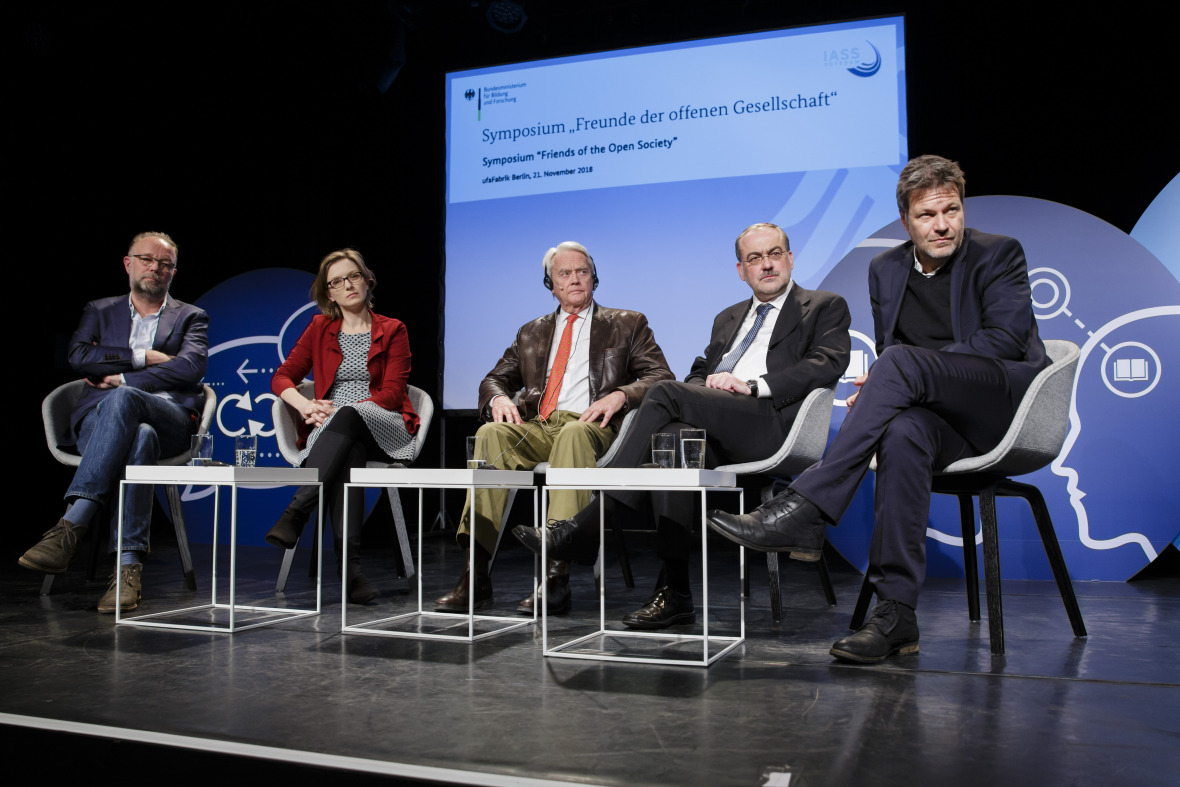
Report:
270,314,418,448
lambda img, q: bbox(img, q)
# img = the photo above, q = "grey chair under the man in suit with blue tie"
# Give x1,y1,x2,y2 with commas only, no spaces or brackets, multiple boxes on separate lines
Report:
717,386,835,623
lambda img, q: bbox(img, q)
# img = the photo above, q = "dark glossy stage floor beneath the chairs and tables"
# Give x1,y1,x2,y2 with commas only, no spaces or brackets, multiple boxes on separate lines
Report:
0,539,1180,786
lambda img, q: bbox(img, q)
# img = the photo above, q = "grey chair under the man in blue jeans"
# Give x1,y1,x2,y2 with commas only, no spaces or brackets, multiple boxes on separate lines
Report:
41,380,217,596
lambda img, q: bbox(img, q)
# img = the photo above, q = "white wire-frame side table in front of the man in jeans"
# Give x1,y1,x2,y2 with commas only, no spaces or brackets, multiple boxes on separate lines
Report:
114,465,323,634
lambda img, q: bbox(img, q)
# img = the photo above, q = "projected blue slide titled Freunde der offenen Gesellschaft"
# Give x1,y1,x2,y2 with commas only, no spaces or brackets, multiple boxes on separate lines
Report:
443,17,906,409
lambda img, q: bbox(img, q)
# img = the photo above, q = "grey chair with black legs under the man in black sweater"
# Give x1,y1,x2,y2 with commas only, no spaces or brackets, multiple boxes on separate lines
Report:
850,340,1086,656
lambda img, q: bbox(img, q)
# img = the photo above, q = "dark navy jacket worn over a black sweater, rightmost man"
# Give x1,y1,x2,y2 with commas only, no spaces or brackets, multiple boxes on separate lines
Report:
868,229,1050,408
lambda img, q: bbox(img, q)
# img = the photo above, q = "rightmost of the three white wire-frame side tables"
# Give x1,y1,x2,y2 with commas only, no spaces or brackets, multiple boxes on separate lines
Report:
538,467,746,667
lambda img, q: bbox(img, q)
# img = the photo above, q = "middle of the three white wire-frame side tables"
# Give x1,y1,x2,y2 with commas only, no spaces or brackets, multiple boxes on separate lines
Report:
340,467,538,642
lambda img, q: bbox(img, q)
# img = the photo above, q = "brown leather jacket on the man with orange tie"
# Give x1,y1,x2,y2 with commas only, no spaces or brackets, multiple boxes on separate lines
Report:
479,303,675,420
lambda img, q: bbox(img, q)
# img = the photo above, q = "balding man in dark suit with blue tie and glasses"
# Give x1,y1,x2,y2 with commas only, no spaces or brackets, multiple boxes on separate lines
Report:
513,224,851,629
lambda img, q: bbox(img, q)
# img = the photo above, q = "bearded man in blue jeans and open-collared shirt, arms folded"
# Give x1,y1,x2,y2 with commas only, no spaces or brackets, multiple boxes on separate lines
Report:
19,232,209,612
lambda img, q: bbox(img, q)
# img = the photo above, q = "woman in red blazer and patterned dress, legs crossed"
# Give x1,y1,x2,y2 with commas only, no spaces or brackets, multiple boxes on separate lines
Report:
267,249,418,604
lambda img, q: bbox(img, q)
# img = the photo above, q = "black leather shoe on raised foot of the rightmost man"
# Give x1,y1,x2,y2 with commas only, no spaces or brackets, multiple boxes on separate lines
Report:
708,488,827,563
